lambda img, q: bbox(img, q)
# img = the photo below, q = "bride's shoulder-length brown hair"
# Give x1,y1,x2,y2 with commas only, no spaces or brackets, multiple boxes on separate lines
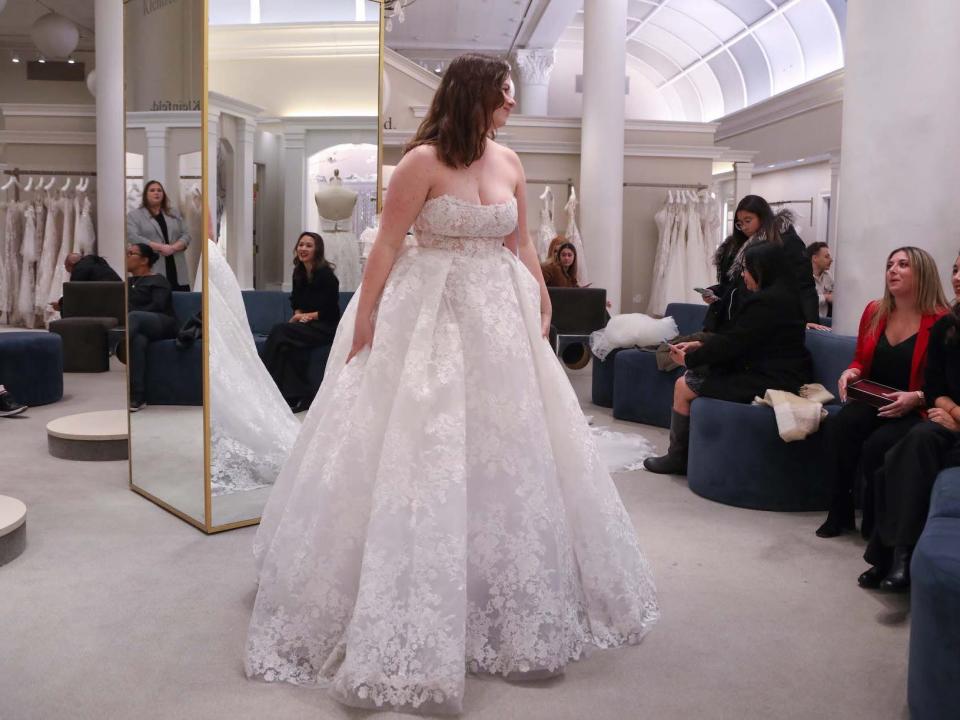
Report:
404,54,510,168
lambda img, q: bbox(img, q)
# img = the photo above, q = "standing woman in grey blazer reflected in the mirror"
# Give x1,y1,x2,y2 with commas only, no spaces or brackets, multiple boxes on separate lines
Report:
127,180,190,290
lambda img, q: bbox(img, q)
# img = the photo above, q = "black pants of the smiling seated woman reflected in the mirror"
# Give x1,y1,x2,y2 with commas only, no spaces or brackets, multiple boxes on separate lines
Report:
263,320,336,402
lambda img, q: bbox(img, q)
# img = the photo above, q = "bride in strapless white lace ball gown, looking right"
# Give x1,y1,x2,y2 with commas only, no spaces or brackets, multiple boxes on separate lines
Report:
246,55,658,712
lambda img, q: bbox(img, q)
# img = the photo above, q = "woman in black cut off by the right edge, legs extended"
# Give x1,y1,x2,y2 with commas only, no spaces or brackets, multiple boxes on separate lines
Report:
858,252,960,592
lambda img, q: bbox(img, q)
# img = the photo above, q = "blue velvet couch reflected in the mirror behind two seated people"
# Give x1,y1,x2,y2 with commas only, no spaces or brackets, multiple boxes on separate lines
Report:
146,290,353,405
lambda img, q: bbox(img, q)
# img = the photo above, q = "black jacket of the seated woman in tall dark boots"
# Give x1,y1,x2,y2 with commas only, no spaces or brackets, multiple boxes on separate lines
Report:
686,281,813,402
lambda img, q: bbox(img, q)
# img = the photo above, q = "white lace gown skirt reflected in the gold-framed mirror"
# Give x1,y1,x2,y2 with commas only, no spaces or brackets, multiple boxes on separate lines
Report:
207,241,300,495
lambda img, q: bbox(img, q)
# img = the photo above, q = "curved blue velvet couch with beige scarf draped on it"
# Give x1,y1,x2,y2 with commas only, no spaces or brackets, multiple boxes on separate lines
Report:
687,330,856,511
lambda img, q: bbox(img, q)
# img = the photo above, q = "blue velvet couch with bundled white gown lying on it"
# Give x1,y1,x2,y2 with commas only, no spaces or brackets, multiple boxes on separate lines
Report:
592,303,707,416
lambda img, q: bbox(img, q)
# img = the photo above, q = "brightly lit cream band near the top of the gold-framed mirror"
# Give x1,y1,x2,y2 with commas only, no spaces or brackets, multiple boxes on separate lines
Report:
209,22,380,60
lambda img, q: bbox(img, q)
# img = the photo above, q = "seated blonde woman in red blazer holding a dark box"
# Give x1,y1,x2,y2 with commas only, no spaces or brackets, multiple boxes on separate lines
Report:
817,247,948,537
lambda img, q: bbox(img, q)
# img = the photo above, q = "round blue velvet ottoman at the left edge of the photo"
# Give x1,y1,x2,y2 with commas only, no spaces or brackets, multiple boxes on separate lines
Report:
0,332,63,405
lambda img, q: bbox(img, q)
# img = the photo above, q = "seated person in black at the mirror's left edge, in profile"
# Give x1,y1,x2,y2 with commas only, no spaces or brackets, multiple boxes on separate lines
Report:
127,243,177,412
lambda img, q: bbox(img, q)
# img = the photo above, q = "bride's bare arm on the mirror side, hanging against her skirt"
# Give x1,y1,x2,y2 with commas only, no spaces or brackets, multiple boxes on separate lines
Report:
347,146,437,362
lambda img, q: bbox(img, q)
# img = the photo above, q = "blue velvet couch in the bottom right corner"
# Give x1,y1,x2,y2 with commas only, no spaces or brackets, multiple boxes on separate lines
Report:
907,468,960,720
